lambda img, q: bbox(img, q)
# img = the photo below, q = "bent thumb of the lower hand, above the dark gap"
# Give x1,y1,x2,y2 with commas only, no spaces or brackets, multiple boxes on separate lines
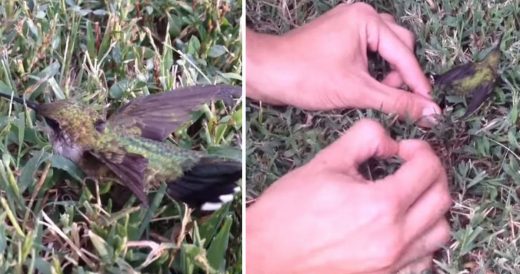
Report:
310,119,399,171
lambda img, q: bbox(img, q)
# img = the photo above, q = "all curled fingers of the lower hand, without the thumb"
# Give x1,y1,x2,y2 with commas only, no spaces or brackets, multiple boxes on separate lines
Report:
375,140,451,274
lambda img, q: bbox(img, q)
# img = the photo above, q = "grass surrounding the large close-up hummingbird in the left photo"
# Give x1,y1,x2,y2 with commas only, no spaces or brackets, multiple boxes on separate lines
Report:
0,0,242,274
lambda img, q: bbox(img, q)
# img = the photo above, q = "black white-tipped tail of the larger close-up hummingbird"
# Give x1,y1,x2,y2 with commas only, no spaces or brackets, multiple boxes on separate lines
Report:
168,157,242,211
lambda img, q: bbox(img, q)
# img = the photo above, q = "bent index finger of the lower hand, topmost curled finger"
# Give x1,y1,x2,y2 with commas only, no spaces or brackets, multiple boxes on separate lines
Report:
376,140,445,212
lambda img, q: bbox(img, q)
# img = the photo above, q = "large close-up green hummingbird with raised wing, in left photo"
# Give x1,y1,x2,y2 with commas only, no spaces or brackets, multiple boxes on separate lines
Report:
0,85,242,211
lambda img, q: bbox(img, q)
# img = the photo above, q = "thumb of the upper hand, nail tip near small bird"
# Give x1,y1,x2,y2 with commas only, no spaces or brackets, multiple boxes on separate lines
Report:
366,78,441,127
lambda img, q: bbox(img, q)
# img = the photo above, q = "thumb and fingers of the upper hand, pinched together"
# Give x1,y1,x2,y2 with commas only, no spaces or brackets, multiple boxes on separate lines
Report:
352,13,441,127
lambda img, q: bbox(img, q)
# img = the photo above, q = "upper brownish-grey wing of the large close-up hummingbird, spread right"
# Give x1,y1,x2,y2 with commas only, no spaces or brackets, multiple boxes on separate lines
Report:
107,85,241,141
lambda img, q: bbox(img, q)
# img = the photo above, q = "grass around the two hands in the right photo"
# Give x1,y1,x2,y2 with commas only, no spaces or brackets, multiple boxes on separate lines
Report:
246,0,520,273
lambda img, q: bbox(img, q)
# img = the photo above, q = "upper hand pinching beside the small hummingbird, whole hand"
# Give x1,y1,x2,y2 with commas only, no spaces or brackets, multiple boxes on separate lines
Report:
246,3,441,126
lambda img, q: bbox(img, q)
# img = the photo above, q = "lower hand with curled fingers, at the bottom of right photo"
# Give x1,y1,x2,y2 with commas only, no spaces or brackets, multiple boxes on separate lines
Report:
246,120,451,273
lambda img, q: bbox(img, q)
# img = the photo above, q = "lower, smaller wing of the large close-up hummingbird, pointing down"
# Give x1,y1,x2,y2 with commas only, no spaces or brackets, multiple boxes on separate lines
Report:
91,152,148,206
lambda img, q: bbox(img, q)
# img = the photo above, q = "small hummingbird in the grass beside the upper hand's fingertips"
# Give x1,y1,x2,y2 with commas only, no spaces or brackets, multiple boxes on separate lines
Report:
435,34,503,118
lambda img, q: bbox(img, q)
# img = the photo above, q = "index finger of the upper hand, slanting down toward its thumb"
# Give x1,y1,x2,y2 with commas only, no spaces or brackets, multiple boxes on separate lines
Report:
366,19,431,98
